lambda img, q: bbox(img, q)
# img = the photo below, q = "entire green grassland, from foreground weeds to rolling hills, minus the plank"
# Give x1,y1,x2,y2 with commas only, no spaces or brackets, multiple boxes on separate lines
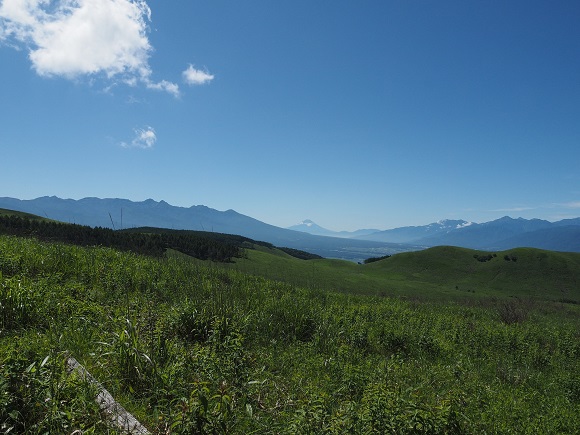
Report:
0,230,580,434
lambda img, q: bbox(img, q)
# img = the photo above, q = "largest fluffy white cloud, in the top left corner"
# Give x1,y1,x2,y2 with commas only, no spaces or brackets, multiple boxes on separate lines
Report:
0,0,179,96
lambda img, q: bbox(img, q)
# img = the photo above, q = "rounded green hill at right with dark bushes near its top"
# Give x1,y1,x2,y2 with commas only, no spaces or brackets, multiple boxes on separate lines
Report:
365,246,580,302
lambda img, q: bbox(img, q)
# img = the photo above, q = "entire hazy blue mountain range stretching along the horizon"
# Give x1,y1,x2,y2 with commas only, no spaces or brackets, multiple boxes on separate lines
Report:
0,196,580,261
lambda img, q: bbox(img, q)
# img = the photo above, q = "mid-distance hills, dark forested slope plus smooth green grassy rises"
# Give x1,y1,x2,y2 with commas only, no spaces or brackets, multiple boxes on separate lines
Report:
0,210,580,303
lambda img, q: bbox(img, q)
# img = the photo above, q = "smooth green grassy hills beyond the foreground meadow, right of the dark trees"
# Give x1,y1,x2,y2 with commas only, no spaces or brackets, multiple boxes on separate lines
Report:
219,246,580,303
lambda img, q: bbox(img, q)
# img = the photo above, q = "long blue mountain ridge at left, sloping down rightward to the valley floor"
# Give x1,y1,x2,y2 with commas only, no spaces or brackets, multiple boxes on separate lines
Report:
0,196,421,261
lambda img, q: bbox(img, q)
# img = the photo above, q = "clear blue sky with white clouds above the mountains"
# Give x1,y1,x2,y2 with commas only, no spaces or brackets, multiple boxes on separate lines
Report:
0,0,580,230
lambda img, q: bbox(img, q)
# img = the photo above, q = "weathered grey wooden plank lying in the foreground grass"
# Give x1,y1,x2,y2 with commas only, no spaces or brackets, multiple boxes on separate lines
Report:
66,357,150,435
